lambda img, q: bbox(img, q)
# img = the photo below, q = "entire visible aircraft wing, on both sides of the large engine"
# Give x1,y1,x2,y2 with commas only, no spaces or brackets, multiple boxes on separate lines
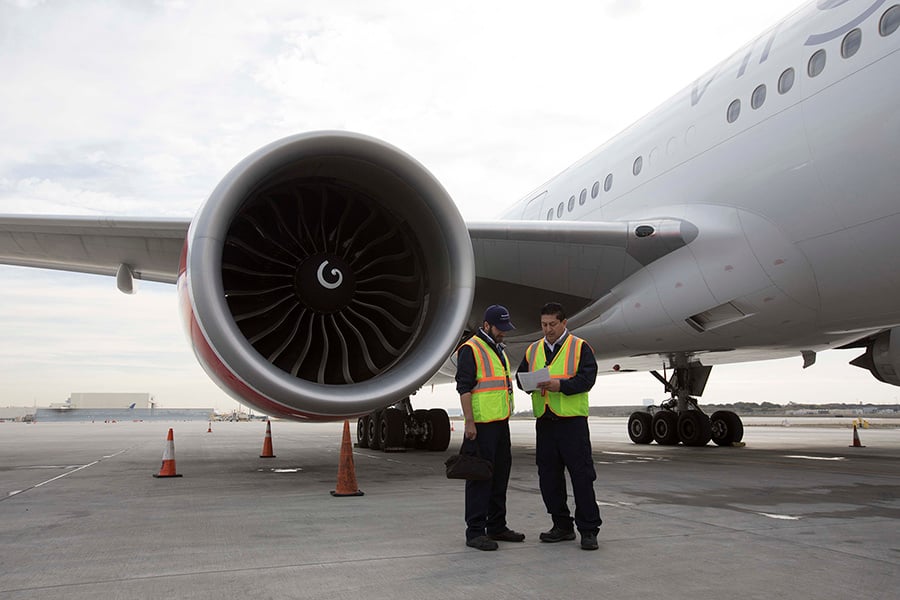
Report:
0,215,696,314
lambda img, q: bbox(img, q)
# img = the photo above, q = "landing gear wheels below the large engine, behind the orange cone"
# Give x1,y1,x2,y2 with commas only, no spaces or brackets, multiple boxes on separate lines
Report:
356,398,450,452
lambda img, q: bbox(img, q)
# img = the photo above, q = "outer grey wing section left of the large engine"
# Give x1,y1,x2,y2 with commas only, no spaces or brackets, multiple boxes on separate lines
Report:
0,215,190,291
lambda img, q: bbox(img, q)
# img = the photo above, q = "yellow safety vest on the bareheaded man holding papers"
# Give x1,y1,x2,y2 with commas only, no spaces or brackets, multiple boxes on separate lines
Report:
525,333,588,417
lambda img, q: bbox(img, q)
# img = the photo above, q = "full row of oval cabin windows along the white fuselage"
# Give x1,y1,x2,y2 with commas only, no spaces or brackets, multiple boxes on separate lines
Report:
547,4,900,221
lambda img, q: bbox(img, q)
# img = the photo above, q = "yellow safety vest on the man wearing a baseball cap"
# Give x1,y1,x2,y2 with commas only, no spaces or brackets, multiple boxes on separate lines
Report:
463,335,513,423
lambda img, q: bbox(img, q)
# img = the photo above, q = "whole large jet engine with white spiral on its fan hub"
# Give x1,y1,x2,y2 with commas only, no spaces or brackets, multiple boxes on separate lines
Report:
179,132,475,419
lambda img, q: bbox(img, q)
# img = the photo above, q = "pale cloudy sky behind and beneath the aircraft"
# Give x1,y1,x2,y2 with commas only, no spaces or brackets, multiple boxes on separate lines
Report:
0,0,900,410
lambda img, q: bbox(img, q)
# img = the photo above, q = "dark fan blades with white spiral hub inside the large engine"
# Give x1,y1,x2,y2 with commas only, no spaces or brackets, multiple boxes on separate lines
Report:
222,178,427,384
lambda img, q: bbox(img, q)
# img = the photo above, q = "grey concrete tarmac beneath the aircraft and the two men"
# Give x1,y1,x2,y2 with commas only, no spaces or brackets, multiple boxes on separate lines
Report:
0,418,900,600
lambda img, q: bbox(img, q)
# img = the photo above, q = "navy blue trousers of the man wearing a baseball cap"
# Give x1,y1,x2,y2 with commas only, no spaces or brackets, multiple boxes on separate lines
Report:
463,421,512,540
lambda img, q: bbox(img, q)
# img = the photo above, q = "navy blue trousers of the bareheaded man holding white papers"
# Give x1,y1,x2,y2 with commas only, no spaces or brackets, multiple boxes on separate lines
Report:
535,417,603,533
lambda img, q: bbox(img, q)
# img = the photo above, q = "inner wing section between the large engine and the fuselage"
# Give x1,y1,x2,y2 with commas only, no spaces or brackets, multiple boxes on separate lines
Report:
467,218,698,337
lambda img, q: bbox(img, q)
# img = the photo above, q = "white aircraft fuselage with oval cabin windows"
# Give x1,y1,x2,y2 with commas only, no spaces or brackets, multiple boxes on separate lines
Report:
504,0,900,368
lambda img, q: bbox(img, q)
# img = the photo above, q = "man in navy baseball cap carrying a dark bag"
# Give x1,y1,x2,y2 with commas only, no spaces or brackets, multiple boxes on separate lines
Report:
456,304,525,550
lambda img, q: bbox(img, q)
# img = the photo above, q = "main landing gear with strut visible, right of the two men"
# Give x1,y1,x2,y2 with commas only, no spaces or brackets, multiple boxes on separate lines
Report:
628,359,744,446
